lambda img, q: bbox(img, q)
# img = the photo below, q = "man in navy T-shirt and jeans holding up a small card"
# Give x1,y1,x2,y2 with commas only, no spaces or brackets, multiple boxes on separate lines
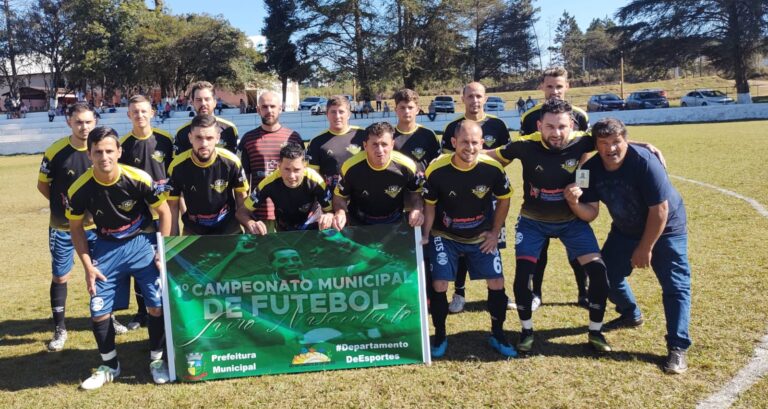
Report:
565,118,691,374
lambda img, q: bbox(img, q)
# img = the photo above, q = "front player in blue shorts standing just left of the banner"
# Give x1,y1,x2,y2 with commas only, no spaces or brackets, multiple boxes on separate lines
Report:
66,127,171,390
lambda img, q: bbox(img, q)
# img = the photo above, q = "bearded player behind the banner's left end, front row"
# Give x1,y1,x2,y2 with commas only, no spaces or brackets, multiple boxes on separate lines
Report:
168,114,248,235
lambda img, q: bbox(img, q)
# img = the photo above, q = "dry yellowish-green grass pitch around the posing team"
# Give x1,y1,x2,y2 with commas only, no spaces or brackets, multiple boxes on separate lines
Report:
0,121,768,408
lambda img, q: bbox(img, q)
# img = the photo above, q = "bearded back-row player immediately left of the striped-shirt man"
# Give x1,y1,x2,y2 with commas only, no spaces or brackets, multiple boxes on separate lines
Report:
173,81,237,155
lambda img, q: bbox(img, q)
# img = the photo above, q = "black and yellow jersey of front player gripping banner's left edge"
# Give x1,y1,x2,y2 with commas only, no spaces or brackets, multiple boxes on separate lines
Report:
66,165,165,240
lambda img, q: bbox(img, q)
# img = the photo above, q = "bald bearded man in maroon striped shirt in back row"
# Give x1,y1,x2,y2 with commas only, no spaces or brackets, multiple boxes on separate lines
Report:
237,91,304,232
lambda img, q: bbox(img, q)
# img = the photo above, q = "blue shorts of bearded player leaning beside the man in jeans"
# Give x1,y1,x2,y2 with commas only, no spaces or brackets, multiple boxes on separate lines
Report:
515,216,600,263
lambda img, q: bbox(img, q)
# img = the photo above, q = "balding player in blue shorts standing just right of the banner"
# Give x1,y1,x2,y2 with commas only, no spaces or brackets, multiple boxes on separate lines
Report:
422,120,517,358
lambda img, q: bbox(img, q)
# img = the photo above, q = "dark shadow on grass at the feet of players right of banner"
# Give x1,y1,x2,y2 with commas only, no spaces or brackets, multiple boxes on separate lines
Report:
437,324,664,365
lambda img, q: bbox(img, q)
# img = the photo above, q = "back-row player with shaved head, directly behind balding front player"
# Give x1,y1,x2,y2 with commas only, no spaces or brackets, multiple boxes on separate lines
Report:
442,82,510,313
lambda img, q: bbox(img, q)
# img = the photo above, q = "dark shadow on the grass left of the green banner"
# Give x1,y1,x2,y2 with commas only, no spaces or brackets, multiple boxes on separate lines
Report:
0,338,159,392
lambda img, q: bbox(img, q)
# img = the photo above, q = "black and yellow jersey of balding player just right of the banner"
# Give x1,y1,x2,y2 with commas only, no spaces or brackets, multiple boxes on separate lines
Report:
424,154,512,243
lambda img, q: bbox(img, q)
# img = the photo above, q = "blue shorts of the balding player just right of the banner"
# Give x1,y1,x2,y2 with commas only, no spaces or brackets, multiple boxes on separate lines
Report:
427,236,504,281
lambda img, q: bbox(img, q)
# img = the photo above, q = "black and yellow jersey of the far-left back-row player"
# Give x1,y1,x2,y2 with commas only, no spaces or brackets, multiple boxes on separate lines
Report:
37,137,92,230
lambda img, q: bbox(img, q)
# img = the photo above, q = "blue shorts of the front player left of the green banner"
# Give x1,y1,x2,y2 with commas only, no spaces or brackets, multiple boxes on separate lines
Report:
91,233,163,317
